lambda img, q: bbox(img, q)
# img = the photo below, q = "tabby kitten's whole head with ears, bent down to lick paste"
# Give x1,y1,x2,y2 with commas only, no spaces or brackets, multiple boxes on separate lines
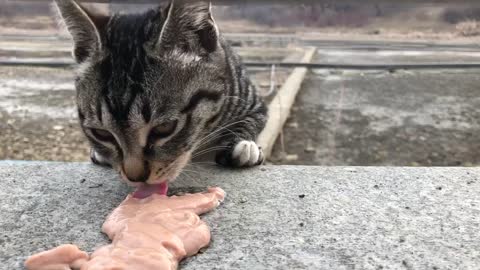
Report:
55,0,227,184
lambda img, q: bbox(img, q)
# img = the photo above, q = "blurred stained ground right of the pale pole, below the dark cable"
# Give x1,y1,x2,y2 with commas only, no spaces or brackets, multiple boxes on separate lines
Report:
273,69,480,166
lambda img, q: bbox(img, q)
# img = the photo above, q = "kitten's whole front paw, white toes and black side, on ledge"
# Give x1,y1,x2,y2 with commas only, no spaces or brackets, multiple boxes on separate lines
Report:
215,140,264,167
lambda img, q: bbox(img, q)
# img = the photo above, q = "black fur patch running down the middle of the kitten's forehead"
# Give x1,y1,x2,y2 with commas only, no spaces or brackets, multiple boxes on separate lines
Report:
100,9,157,126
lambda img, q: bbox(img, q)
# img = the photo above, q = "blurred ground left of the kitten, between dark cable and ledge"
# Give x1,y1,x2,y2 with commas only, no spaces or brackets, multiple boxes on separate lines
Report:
0,66,88,161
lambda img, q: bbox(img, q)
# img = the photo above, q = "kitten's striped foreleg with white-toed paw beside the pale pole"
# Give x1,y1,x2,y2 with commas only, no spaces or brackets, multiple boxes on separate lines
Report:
215,109,266,167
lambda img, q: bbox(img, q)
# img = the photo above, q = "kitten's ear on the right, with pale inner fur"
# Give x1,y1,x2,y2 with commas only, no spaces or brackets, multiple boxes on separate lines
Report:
157,0,219,54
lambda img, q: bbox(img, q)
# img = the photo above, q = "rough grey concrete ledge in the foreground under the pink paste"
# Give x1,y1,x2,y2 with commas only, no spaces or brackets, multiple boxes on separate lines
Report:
0,162,480,270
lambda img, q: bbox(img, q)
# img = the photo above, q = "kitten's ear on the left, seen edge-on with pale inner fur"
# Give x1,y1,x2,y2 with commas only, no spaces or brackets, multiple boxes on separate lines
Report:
55,0,109,63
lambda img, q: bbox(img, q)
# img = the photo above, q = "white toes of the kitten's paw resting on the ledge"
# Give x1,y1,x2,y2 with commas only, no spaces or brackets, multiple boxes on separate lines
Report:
232,141,263,166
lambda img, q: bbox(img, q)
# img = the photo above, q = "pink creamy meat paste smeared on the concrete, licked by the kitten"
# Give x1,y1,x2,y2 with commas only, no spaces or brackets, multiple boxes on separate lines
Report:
25,188,225,270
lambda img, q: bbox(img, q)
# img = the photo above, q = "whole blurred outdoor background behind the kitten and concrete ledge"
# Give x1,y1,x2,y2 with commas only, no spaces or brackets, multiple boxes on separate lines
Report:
0,0,480,166
